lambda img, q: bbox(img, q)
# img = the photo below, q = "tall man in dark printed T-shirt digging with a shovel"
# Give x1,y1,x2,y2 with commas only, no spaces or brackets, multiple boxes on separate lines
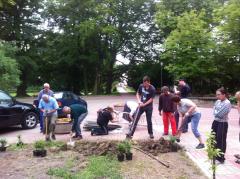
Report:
126,76,156,139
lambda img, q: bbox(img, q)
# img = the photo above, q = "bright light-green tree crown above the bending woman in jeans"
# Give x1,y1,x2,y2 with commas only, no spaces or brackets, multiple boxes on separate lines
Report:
164,11,217,93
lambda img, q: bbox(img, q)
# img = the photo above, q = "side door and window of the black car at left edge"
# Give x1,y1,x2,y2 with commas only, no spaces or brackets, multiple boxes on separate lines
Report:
0,91,22,127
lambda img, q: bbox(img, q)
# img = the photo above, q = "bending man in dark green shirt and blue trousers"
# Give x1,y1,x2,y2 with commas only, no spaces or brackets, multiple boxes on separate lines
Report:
63,104,88,139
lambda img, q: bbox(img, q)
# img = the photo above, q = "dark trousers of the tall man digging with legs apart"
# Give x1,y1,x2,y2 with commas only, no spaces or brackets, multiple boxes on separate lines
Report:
128,106,153,136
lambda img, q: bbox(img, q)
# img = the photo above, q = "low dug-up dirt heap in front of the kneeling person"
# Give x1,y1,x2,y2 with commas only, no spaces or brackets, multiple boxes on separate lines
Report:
74,140,119,156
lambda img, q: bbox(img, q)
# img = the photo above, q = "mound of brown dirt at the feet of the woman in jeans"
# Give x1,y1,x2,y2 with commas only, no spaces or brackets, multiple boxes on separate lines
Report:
137,137,182,156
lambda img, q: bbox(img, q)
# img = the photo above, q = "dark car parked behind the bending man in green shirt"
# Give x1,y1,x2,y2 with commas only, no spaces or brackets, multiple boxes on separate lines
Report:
53,91,87,117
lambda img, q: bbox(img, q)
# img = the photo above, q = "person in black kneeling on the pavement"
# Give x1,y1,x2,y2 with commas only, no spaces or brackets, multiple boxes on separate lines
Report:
91,107,116,135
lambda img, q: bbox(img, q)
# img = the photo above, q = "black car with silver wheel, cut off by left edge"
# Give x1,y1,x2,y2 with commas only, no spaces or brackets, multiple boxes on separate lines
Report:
0,90,39,129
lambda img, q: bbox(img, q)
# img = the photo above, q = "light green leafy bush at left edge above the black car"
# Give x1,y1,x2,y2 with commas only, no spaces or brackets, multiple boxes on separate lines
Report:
0,41,20,90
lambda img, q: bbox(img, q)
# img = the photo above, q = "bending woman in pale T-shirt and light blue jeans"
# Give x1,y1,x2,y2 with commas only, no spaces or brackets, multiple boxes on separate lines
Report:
172,96,204,149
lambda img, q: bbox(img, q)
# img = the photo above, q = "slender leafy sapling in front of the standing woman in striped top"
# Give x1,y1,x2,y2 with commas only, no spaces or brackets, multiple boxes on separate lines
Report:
206,131,222,179
